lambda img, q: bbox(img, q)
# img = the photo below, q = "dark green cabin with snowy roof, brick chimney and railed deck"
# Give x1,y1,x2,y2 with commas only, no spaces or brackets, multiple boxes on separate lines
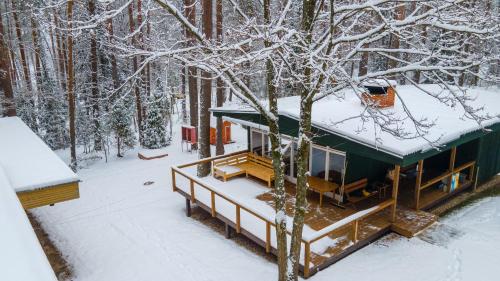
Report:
172,85,500,277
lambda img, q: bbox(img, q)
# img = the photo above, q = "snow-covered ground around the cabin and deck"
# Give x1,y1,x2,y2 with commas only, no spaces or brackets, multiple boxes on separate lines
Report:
33,123,500,281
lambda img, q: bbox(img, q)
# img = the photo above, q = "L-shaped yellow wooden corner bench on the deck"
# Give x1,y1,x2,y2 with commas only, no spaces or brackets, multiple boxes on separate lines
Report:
212,153,274,187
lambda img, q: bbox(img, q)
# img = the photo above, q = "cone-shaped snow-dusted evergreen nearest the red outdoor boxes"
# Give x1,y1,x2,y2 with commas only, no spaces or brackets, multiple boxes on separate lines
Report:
142,98,170,149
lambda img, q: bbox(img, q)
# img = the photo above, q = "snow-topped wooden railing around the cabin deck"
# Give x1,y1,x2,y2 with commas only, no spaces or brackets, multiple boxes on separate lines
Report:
171,151,395,278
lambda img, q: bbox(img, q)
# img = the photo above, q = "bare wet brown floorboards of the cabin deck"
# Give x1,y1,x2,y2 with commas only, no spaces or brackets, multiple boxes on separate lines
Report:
257,179,437,268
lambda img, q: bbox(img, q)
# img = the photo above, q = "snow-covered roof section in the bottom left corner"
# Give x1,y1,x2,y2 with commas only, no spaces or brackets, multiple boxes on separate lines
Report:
0,166,57,281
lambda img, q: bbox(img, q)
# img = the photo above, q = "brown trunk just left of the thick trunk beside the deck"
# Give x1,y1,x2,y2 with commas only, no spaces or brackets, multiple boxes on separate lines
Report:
184,0,198,139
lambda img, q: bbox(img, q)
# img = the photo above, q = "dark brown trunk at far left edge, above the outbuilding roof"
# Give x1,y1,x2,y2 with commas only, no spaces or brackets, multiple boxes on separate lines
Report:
0,8,16,116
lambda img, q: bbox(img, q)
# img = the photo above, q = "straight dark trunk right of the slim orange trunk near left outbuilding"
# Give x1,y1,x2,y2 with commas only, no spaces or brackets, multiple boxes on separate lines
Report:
88,0,102,151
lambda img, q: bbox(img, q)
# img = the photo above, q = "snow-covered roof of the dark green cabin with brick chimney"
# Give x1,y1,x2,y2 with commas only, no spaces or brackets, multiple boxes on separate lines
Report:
212,85,500,158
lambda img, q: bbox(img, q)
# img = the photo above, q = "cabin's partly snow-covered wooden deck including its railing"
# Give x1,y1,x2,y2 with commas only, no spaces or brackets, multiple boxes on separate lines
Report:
172,153,437,278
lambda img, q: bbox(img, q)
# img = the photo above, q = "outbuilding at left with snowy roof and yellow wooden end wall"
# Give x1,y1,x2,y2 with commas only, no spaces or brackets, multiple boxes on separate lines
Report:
0,117,80,209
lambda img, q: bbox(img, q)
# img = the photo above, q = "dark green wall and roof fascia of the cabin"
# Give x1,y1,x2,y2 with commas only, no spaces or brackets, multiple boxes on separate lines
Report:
214,111,500,183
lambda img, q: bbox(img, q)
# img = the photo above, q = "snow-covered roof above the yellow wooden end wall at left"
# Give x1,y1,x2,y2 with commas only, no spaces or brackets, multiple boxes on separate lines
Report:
0,117,78,192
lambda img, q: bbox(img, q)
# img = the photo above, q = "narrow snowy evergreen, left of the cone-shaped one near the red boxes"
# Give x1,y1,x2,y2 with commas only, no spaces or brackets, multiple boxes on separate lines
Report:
110,101,135,157
